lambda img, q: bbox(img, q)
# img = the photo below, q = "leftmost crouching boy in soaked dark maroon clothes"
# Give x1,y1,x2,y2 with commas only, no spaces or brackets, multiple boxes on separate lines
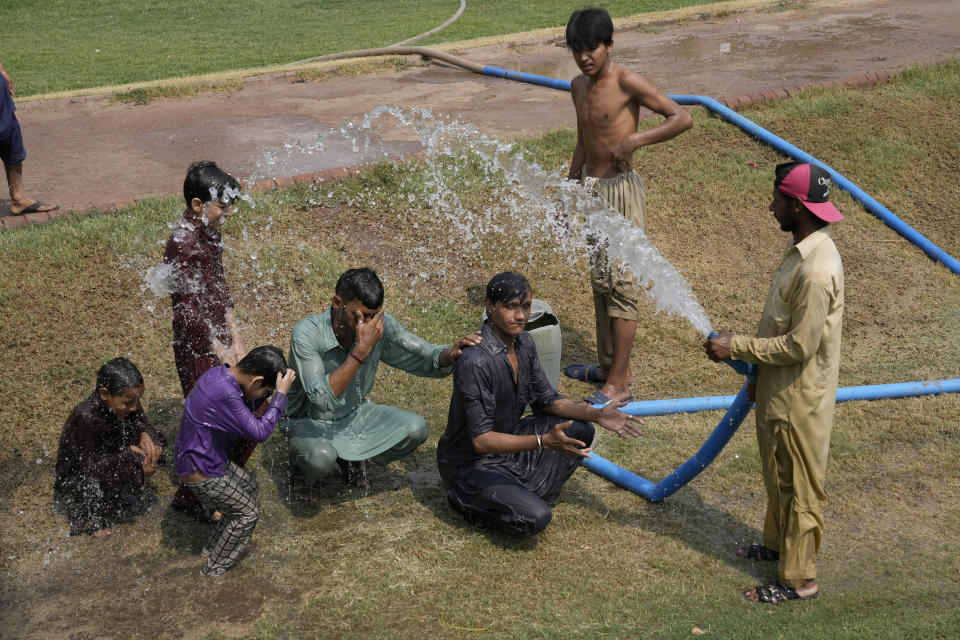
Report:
54,358,166,537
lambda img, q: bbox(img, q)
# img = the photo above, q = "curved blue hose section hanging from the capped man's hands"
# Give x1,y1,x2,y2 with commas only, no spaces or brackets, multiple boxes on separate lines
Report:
583,333,756,502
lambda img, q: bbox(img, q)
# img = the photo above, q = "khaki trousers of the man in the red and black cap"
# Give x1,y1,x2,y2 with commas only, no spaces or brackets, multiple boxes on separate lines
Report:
757,420,830,589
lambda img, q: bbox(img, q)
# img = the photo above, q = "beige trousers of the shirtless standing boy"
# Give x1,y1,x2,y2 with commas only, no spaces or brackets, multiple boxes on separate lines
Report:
583,171,647,369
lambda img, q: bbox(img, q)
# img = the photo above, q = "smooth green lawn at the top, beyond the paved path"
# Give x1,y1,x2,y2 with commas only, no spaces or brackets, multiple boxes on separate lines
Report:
0,0,718,98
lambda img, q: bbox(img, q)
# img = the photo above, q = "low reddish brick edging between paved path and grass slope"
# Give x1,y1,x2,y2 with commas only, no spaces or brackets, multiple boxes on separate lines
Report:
0,71,894,229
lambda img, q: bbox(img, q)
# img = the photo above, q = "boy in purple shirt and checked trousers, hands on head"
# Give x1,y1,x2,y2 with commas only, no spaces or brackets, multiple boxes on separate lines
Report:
175,346,296,576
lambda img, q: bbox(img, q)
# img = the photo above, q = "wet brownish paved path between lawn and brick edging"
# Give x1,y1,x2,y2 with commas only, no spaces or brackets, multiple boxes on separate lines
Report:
0,0,960,216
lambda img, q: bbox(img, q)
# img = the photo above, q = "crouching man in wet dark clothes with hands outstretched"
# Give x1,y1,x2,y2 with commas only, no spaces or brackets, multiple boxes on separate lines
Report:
437,272,642,537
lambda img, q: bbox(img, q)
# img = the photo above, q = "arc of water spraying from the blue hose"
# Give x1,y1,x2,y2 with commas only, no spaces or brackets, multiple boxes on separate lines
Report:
131,105,710,344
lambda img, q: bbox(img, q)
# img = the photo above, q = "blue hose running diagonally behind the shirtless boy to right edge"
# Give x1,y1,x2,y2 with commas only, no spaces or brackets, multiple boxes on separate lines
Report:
481,66,960,274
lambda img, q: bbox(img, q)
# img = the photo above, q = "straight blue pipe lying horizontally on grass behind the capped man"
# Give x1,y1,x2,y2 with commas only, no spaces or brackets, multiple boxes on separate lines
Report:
620,378,960,416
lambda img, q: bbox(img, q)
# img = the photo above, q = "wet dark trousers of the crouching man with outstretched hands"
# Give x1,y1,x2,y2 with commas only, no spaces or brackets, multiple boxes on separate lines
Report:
446,416,594,538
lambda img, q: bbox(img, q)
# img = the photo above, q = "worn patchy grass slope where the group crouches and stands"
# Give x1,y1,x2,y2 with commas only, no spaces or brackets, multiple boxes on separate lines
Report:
0,62,960,640
